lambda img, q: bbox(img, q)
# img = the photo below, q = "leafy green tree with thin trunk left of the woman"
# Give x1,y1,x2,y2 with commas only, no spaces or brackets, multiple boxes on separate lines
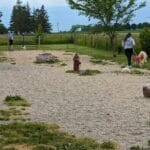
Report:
67,0,146,56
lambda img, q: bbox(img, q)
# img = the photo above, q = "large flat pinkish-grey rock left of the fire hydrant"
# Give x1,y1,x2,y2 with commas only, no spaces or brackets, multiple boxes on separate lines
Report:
36,53,58,63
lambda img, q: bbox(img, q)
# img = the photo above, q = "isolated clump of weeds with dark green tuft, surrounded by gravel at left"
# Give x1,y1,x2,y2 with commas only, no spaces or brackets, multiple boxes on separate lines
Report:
4,95,30,106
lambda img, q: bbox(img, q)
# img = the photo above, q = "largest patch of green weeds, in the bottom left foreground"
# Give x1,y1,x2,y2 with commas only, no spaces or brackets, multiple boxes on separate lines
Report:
0,122,103,150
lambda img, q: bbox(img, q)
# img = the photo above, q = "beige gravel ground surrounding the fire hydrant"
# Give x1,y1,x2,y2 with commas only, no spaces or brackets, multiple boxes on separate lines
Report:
0,51,150,150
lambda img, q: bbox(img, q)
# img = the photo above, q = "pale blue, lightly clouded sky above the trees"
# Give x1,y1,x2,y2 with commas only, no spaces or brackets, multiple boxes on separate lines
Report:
0,0,150,32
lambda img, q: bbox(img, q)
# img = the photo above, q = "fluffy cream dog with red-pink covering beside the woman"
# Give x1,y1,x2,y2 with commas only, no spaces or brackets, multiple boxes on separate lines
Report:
133,51,147,66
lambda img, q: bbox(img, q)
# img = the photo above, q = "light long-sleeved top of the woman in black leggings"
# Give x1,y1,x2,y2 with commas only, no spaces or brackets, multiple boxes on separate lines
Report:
122,37,135,49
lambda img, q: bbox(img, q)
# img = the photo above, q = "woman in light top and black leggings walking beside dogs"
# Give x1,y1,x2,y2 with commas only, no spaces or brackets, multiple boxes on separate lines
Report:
122,33,135,69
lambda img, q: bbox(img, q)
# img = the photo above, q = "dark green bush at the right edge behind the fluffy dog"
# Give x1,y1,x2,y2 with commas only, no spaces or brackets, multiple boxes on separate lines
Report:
140,28,150,56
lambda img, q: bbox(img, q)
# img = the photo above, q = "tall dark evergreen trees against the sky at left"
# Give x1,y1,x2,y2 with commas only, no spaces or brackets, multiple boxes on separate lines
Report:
0,0,52,34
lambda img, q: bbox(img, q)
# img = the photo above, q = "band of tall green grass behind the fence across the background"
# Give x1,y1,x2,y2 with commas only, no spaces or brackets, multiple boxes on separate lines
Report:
0,32,141,51
